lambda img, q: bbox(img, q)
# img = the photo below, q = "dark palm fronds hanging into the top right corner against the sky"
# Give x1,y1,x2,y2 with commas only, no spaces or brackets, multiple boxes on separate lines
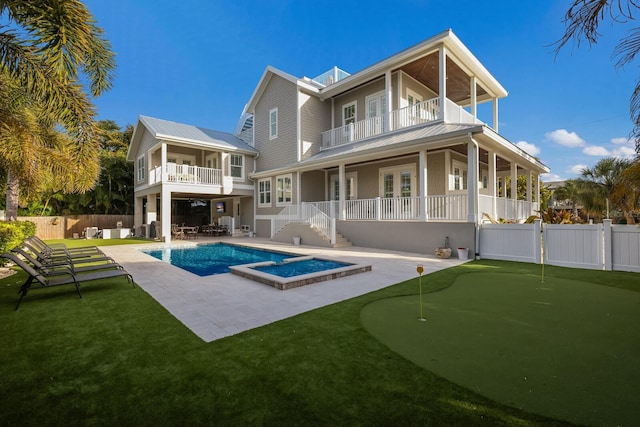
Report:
556,0,640,155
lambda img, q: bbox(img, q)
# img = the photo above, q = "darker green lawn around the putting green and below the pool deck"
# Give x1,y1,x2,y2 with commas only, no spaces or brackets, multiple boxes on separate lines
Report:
0,240,640,426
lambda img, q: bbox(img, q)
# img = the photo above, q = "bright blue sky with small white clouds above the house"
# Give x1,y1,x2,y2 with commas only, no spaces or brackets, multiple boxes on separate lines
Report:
85,0,638,181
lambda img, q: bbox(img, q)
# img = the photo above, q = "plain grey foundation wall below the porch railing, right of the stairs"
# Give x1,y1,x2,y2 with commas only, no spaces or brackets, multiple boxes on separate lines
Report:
336,221,476,258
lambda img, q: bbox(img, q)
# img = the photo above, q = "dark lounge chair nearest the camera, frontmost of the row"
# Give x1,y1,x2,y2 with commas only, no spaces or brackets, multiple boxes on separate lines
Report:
0,254,136,310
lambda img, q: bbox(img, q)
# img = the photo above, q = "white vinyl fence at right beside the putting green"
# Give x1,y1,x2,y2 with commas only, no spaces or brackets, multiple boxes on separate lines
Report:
478,220,640,272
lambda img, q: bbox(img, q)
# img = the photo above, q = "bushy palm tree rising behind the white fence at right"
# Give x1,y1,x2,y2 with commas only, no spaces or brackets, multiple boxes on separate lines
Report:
577,157,638,224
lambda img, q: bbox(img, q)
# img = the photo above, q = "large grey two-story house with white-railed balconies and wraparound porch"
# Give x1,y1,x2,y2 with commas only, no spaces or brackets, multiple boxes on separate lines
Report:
129,30,549,253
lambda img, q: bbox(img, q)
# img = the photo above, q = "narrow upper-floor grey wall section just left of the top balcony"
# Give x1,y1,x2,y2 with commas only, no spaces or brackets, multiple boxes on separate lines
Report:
298,93,331,160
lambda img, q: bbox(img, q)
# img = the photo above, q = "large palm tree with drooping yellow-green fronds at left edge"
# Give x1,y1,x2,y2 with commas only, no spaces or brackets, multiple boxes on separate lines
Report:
0,0,115,216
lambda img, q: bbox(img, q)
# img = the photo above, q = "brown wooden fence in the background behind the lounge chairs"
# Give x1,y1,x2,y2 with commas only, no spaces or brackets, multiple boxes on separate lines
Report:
18,215,133,239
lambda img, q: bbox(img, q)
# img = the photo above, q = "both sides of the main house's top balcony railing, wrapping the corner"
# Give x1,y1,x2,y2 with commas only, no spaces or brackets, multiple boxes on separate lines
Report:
322,98,480,149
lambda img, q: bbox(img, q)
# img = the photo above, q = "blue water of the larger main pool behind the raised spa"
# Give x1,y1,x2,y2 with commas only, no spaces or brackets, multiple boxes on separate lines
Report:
143,243,297,276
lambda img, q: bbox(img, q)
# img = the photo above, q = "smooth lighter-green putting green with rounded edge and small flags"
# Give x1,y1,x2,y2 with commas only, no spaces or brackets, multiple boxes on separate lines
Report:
360,273,640,425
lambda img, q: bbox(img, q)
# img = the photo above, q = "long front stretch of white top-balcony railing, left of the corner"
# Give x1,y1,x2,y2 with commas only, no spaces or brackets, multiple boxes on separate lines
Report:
322,98,440,148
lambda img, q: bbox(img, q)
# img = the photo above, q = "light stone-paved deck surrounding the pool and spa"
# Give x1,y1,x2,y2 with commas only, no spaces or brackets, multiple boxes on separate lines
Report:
101,237,464,342
